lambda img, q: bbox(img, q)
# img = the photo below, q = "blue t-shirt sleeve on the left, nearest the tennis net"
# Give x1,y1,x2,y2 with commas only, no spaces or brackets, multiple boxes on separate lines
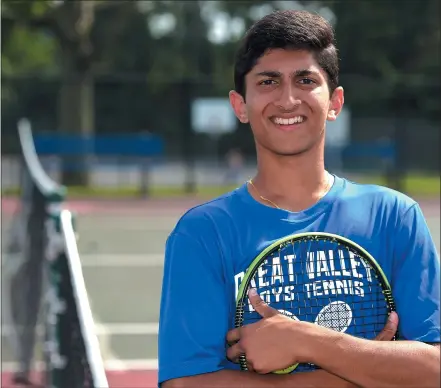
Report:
158,232,229,384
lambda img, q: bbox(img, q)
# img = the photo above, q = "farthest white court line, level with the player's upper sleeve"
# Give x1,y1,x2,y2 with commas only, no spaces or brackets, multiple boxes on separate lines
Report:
80,253,164,268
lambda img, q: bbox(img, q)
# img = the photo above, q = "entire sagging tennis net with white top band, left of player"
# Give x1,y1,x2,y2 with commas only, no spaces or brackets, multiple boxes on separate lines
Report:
2,119,108,388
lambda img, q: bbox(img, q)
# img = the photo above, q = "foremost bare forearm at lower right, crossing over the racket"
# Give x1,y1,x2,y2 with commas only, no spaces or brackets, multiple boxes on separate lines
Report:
311,333,440,388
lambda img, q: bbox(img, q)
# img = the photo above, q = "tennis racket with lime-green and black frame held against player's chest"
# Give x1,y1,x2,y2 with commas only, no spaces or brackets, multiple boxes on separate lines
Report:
235,233,397,374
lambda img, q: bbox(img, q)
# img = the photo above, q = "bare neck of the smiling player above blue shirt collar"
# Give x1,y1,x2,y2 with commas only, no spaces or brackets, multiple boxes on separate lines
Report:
251,141,330,212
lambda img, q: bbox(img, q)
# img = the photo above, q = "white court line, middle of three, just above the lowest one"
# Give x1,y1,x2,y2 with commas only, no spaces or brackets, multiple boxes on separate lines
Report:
1,322,159,336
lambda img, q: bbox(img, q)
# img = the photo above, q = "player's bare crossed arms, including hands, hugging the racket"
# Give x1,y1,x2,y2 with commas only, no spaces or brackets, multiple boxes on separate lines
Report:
162,295,440,388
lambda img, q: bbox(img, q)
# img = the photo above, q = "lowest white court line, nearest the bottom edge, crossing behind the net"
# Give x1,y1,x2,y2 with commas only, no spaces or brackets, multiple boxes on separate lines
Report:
1,358,158,373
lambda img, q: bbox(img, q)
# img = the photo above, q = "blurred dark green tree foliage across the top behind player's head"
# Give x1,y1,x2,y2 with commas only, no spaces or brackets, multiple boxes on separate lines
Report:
2,0,440,146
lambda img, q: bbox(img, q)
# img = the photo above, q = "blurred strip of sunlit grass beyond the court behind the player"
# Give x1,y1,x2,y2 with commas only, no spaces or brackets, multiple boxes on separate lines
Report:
3,174,440,199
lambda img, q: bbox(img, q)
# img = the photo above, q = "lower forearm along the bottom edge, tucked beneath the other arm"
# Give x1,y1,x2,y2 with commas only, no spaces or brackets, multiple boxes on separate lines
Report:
161,370,355,388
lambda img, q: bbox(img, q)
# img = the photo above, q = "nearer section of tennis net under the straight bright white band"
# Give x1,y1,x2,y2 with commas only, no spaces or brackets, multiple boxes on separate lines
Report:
45,210,108,388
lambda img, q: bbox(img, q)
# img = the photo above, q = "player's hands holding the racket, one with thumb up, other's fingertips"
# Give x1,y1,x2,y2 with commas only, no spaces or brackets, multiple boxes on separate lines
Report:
227,289,398,374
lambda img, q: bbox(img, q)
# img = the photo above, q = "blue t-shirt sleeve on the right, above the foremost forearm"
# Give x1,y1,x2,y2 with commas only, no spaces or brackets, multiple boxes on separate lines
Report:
392,204,440,342
